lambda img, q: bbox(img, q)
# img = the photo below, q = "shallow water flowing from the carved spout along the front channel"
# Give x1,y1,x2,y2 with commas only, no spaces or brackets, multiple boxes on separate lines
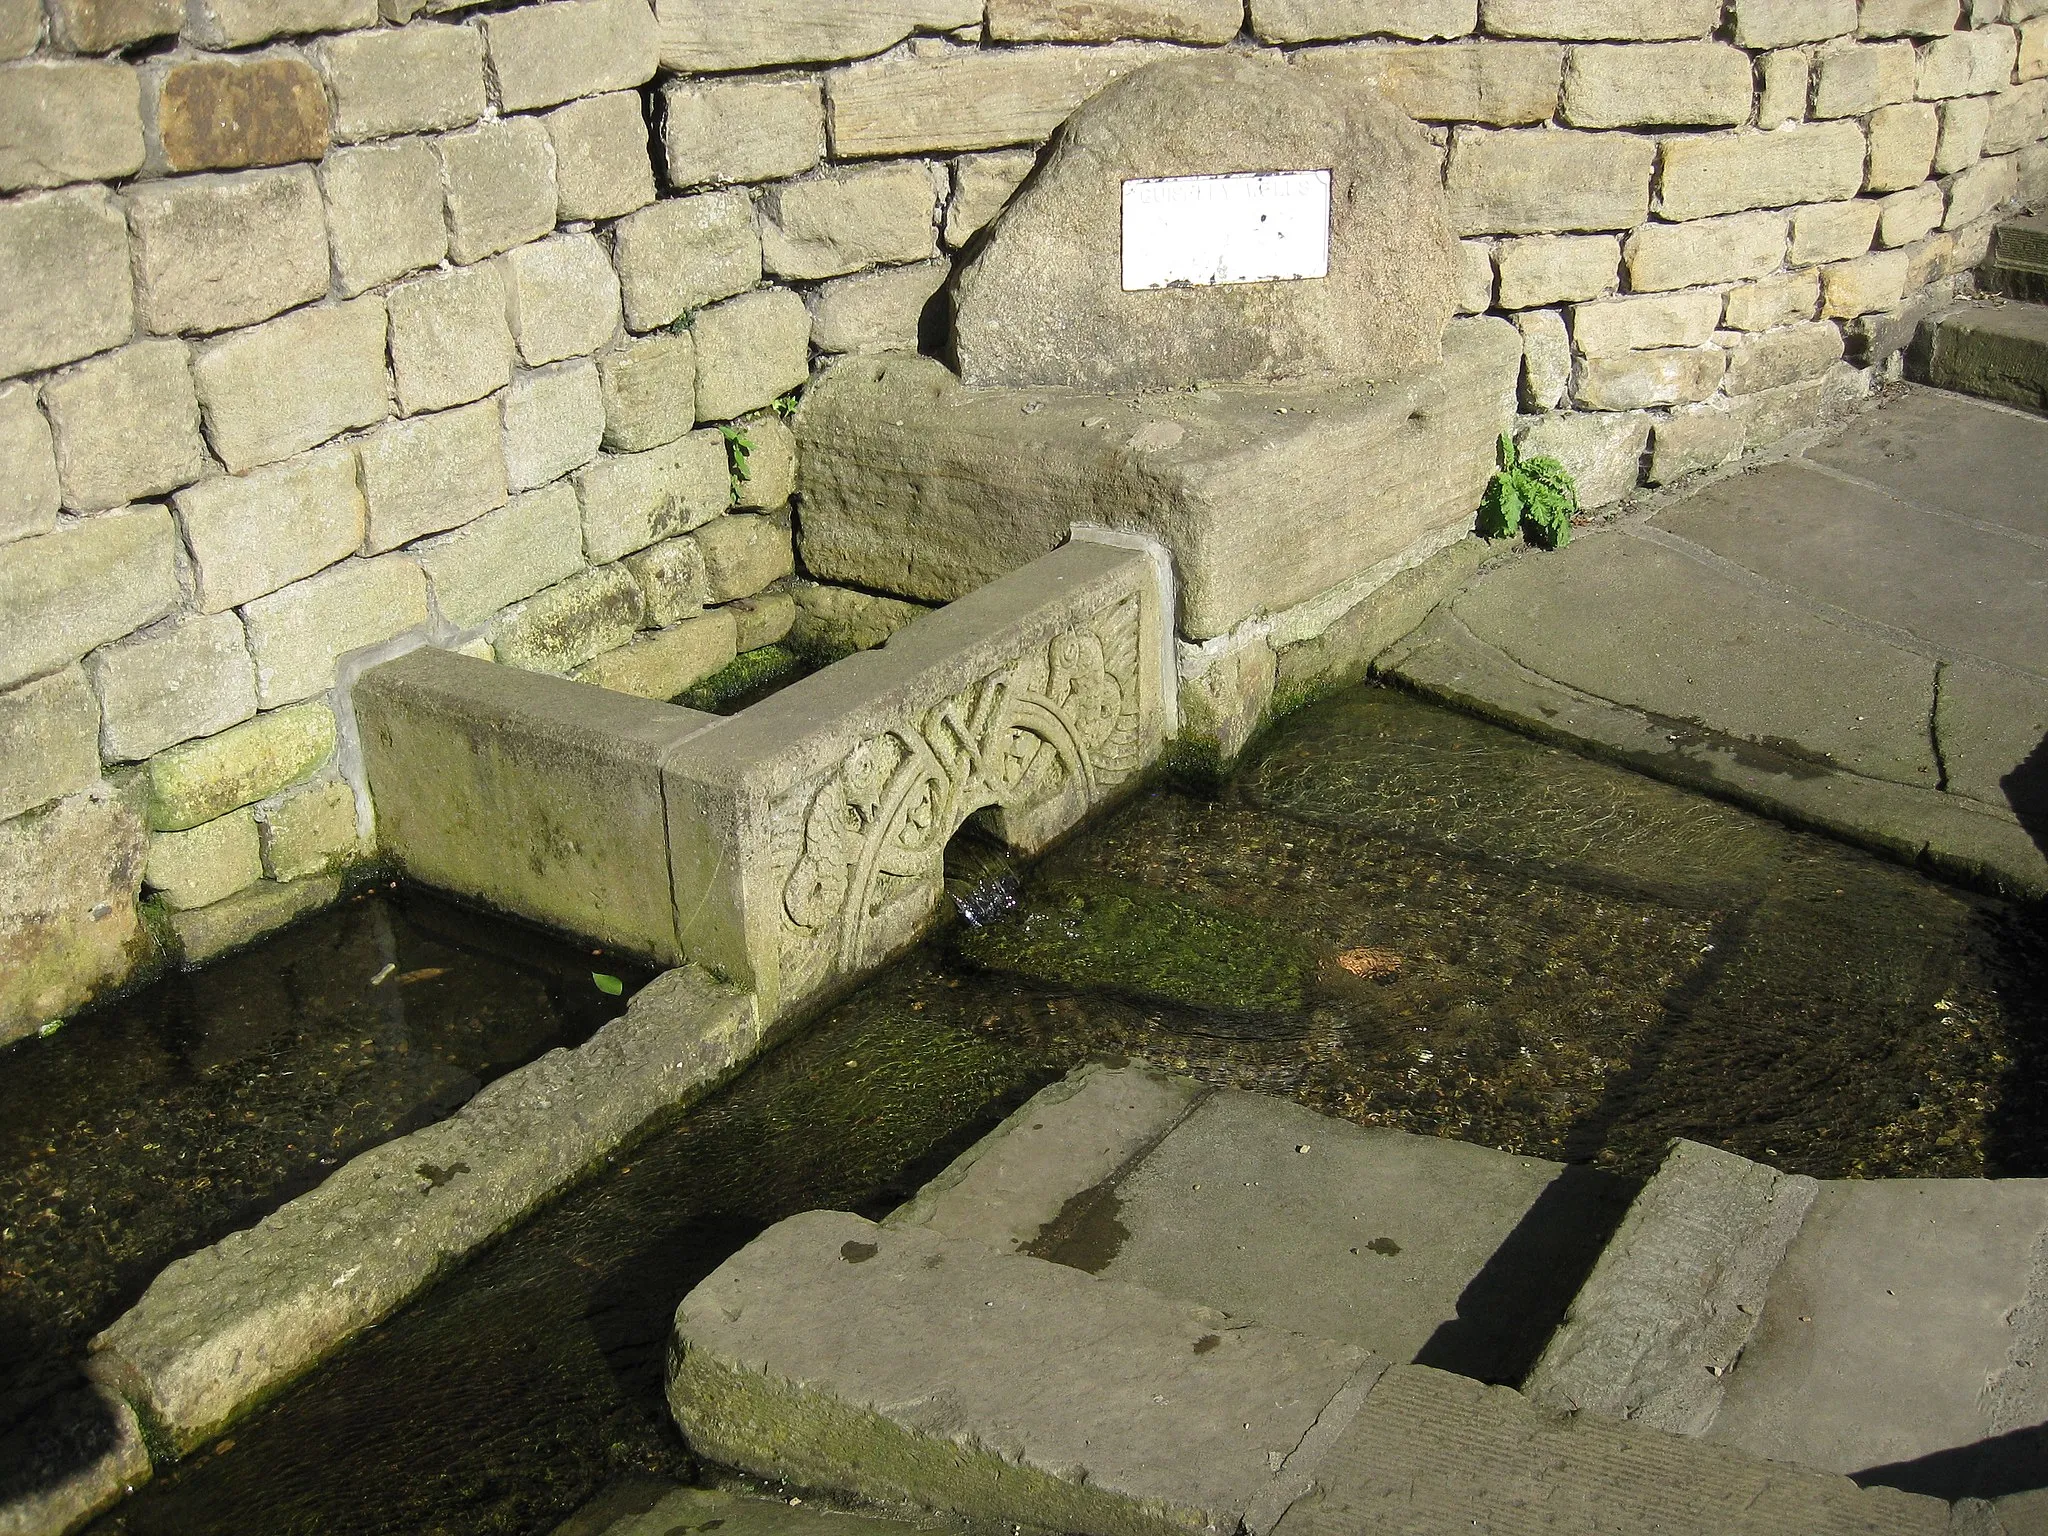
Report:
0,688,2048,1536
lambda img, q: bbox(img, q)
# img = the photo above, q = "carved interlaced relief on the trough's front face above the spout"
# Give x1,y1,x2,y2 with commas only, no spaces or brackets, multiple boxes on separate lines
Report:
770,598,1141,995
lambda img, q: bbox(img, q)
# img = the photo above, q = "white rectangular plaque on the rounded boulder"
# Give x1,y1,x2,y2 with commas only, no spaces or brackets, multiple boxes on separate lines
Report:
1124,170,1329,293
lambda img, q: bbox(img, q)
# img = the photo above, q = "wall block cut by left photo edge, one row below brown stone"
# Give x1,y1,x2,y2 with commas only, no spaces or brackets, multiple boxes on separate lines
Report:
0,186,135,377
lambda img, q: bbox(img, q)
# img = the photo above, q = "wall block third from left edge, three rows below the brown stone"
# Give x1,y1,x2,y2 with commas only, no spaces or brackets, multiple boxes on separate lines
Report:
356,399,506,561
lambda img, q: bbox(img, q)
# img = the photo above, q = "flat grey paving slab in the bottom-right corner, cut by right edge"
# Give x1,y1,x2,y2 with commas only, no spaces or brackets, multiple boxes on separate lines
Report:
1708,1180,2048,1497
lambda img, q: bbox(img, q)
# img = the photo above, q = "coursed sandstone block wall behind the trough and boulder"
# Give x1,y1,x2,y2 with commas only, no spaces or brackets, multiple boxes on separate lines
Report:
0,0,2048,1040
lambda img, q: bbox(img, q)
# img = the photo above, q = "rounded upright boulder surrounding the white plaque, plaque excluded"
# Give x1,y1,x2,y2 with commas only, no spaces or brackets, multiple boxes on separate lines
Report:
954,55,1460,391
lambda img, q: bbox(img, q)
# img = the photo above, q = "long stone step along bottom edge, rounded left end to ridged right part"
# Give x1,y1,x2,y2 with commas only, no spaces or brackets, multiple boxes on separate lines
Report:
668,1212,1950,1536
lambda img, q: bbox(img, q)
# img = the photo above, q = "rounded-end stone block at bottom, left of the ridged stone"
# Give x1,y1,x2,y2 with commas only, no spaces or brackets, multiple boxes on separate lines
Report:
668,1210,1384,1536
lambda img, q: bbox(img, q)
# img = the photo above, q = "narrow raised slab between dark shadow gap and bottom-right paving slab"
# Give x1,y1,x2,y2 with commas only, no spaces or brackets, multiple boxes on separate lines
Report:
1522,1141,1821,1434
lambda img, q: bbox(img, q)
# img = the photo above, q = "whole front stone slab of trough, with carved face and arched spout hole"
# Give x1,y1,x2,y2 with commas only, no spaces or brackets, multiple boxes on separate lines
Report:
664,541,1174,1018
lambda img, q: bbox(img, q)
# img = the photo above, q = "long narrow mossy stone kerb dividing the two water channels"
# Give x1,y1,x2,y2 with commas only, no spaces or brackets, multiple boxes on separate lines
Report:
86,966,760,1454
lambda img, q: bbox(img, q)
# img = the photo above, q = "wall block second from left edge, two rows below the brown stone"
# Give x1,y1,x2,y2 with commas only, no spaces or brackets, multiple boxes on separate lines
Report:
43,340,207,512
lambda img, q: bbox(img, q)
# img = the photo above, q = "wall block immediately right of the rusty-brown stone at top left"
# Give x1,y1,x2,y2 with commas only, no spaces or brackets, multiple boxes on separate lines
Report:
313,23,489,143
